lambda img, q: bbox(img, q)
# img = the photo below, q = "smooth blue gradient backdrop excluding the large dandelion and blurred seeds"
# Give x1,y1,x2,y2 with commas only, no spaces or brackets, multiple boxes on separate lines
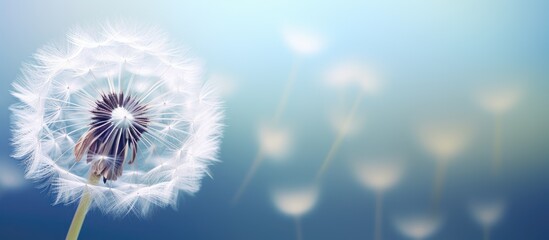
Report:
0,0,549,240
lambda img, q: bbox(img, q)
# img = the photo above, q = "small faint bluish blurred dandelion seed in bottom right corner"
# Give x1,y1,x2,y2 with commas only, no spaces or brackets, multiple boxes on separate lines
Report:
470,200,505,240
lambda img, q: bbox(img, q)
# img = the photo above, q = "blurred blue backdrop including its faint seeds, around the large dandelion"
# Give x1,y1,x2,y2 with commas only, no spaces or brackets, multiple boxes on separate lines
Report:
0,0,549,240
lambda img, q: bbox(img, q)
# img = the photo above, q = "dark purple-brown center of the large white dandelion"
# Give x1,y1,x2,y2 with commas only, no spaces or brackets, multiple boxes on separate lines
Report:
74,92,150,182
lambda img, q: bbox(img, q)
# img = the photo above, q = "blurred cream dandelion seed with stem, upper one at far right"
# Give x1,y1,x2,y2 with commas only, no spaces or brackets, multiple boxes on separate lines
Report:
477,82,523,173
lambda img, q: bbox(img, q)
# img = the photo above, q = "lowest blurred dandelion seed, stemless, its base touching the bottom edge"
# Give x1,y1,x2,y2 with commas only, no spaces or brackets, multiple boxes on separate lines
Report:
396,215,441,240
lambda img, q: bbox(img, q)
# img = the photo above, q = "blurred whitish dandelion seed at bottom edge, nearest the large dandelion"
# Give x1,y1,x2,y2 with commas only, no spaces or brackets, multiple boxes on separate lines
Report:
273,186,318,240
